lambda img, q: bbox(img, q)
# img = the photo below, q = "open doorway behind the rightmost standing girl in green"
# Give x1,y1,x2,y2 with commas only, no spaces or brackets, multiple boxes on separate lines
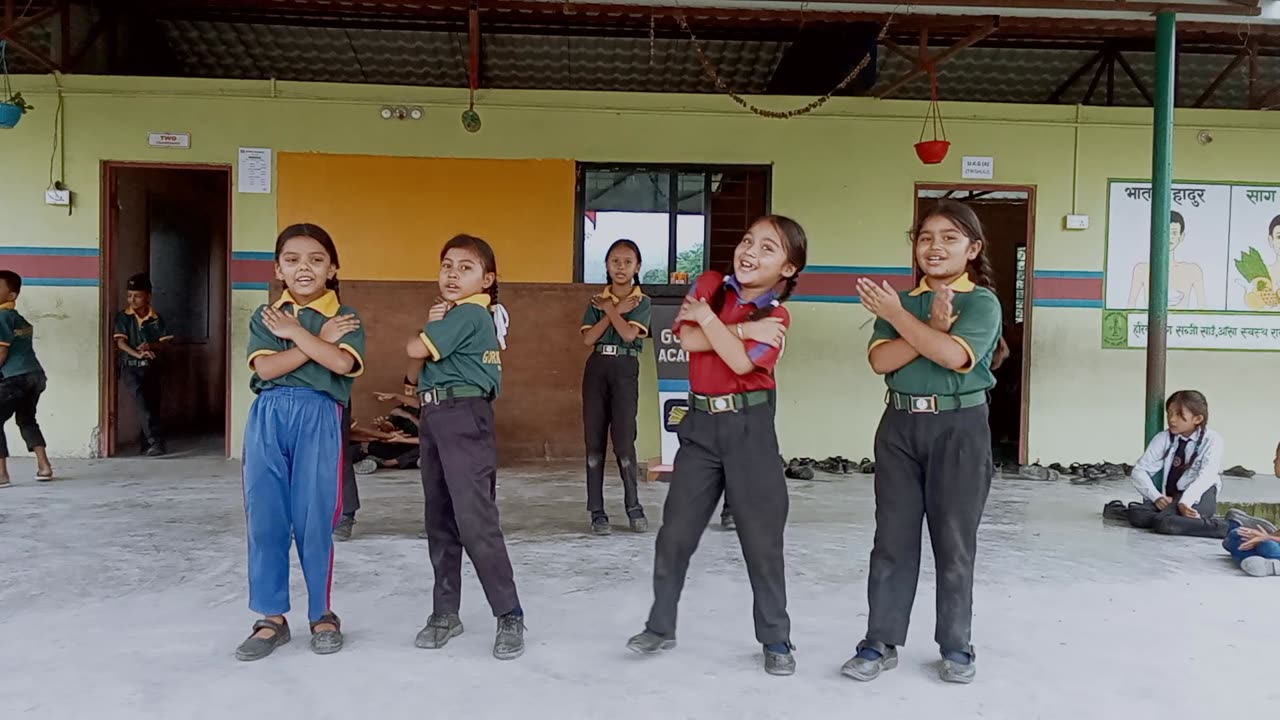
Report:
913,183,1036,465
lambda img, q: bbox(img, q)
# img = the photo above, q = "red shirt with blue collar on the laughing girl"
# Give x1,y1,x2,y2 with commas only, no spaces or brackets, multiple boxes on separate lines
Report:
672,270,791,395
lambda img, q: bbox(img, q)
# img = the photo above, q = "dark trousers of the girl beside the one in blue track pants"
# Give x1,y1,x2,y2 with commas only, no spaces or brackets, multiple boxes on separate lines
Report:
419,397,520,616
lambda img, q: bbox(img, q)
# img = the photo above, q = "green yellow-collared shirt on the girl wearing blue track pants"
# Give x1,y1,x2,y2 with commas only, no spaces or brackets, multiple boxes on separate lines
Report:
248,291,365,405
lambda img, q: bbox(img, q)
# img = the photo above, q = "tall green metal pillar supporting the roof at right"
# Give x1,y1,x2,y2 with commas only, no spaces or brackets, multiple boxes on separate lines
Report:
1147,12,1176,442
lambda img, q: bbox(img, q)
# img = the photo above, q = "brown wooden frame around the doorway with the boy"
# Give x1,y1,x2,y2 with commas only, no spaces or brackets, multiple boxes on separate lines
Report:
97,160,234,457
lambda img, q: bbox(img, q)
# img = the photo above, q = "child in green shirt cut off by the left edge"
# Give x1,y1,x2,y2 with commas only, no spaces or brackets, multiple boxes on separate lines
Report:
0,270,54,488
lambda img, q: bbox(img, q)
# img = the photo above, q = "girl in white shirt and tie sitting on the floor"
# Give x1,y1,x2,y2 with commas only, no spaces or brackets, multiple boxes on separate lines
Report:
1103,389,1228,538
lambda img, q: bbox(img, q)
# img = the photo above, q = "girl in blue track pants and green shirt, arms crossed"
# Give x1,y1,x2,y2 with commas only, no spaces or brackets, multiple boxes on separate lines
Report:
236,224,365,660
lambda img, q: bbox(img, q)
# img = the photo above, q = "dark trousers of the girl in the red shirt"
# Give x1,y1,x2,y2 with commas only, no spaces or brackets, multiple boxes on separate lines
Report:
646,405,791,644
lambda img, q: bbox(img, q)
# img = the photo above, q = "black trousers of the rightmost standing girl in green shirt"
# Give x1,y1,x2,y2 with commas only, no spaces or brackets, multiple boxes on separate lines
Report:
865,405,995,652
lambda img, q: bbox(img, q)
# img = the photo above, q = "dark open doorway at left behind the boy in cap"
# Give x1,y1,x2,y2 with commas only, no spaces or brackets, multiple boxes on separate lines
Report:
99,161,230,457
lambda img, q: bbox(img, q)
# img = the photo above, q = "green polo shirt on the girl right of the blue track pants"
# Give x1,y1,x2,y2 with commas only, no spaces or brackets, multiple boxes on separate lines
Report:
417,295,502,397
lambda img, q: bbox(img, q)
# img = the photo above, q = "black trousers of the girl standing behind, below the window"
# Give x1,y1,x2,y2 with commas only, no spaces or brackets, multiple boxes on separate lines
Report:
582,352,644,518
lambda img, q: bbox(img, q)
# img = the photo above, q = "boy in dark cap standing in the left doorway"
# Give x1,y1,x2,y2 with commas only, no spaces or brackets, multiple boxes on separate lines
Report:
113,273,173,457
